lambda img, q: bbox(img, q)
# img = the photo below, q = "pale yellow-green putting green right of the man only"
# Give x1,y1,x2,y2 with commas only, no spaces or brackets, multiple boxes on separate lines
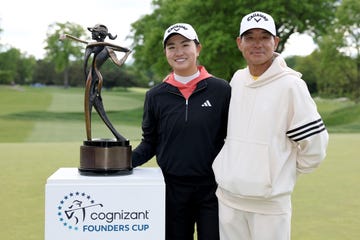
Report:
292,134,360,240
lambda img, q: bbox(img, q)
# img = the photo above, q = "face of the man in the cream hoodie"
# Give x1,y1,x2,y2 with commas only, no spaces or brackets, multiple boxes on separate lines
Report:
236,28,279,70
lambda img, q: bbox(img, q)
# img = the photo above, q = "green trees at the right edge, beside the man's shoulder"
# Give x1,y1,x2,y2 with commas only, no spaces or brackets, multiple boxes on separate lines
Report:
287,0,360,102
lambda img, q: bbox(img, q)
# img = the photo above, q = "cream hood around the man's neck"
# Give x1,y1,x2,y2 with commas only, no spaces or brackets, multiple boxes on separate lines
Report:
245,53,302,87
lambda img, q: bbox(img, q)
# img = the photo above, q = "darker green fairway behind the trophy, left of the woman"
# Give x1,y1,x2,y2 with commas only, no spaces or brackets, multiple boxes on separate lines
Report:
0,86,145,142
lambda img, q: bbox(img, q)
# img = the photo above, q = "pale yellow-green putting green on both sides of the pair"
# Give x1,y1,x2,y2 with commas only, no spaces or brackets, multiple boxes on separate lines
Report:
0,134,360,240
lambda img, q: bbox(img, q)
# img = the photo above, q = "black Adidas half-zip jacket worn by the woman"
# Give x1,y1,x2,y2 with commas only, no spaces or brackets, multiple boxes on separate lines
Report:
132,77,231,179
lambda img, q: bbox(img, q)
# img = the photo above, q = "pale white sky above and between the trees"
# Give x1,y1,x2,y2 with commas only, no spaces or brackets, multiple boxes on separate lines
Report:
0,0,316,59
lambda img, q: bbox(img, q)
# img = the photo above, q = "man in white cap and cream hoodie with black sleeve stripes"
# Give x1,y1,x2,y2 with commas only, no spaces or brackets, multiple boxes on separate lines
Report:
213,12,328,240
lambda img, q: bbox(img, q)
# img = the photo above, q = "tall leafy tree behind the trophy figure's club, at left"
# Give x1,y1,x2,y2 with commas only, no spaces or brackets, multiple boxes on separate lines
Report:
45,22,86,87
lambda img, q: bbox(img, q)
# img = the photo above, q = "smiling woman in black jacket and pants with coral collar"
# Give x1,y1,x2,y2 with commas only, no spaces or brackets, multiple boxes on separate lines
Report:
132,23,231,240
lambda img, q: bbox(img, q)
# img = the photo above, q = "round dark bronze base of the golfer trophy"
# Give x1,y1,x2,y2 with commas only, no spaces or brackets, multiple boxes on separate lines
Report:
78,139,132,176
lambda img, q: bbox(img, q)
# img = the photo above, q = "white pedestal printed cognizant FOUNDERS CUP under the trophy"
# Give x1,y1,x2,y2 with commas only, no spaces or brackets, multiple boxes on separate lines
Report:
45,168,165,240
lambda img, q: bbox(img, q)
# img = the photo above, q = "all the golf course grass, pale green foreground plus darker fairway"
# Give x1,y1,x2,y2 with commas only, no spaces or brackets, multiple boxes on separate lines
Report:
0,86,360,240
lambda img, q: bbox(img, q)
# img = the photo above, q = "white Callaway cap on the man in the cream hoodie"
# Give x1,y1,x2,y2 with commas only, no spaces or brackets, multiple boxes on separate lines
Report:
240,12,276,36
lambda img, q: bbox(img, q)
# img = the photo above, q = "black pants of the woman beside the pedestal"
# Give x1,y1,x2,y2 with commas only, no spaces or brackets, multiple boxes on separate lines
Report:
165,176,220,240
